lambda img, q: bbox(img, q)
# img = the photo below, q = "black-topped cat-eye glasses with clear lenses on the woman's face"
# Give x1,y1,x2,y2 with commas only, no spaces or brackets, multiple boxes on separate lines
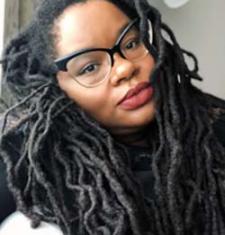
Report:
55,19,153,87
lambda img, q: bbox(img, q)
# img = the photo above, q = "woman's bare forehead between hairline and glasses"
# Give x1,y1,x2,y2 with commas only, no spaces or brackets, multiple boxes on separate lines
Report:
54,0,130,56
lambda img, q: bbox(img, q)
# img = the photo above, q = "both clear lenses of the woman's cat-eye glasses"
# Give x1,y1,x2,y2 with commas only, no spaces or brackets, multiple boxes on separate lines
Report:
67,21,148,87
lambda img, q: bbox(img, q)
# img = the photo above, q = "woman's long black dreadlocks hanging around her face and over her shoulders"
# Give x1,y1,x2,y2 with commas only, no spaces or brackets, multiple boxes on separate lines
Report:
0,0,225,235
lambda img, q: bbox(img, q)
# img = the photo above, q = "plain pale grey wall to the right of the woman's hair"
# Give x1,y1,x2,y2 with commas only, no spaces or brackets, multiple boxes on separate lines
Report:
148,0,225,99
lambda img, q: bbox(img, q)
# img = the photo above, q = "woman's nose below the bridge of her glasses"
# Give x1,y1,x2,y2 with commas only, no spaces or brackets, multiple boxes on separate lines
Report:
110,53,136,86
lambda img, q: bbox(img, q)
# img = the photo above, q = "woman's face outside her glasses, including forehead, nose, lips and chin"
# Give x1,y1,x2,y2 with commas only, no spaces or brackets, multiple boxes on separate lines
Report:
54,0,155,135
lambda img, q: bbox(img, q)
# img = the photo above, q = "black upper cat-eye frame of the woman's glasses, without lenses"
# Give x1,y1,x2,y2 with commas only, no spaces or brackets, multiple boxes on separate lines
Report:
54,18,152,71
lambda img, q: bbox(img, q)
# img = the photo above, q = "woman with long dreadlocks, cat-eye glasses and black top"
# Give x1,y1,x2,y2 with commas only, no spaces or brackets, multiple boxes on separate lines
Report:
1,0,225,235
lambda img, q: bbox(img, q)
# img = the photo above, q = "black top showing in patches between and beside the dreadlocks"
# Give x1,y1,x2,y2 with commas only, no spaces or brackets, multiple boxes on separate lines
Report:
0,114,225,224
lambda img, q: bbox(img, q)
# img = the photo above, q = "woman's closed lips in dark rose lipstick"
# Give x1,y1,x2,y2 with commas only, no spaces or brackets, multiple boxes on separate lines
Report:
118,82,153,110
